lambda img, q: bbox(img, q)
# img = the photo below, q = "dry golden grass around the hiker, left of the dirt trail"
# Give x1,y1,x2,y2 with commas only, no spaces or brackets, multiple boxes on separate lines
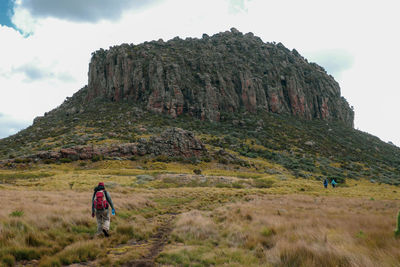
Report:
0,190,156,266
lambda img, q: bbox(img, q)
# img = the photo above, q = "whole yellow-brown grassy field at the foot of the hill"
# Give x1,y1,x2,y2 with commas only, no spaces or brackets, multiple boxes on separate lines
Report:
0,159,400,266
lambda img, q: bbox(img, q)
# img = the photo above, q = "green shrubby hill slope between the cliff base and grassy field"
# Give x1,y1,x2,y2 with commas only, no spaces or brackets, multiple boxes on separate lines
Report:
0,85,400,185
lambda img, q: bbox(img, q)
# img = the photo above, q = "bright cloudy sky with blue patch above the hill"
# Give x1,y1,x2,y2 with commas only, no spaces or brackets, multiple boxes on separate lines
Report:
0,0,400,146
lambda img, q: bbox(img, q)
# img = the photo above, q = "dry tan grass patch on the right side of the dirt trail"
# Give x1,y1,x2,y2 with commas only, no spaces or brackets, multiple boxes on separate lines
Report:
162,195,400,267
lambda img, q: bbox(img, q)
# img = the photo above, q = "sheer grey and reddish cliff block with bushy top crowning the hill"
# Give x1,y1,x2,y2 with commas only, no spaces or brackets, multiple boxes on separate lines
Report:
87,29,354,126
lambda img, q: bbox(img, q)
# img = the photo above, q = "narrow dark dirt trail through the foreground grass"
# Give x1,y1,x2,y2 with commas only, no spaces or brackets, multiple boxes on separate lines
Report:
122,216,177,267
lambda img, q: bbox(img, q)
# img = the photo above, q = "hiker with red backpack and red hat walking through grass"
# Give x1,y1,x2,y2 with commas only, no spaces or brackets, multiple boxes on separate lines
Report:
92,182,115,237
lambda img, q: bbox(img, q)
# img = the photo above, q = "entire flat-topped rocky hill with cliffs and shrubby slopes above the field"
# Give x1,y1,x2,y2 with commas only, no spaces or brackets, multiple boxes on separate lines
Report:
0,29,400,185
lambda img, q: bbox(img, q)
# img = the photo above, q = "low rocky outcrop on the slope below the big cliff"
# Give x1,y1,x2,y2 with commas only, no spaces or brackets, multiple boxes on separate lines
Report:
11,128,208,161
